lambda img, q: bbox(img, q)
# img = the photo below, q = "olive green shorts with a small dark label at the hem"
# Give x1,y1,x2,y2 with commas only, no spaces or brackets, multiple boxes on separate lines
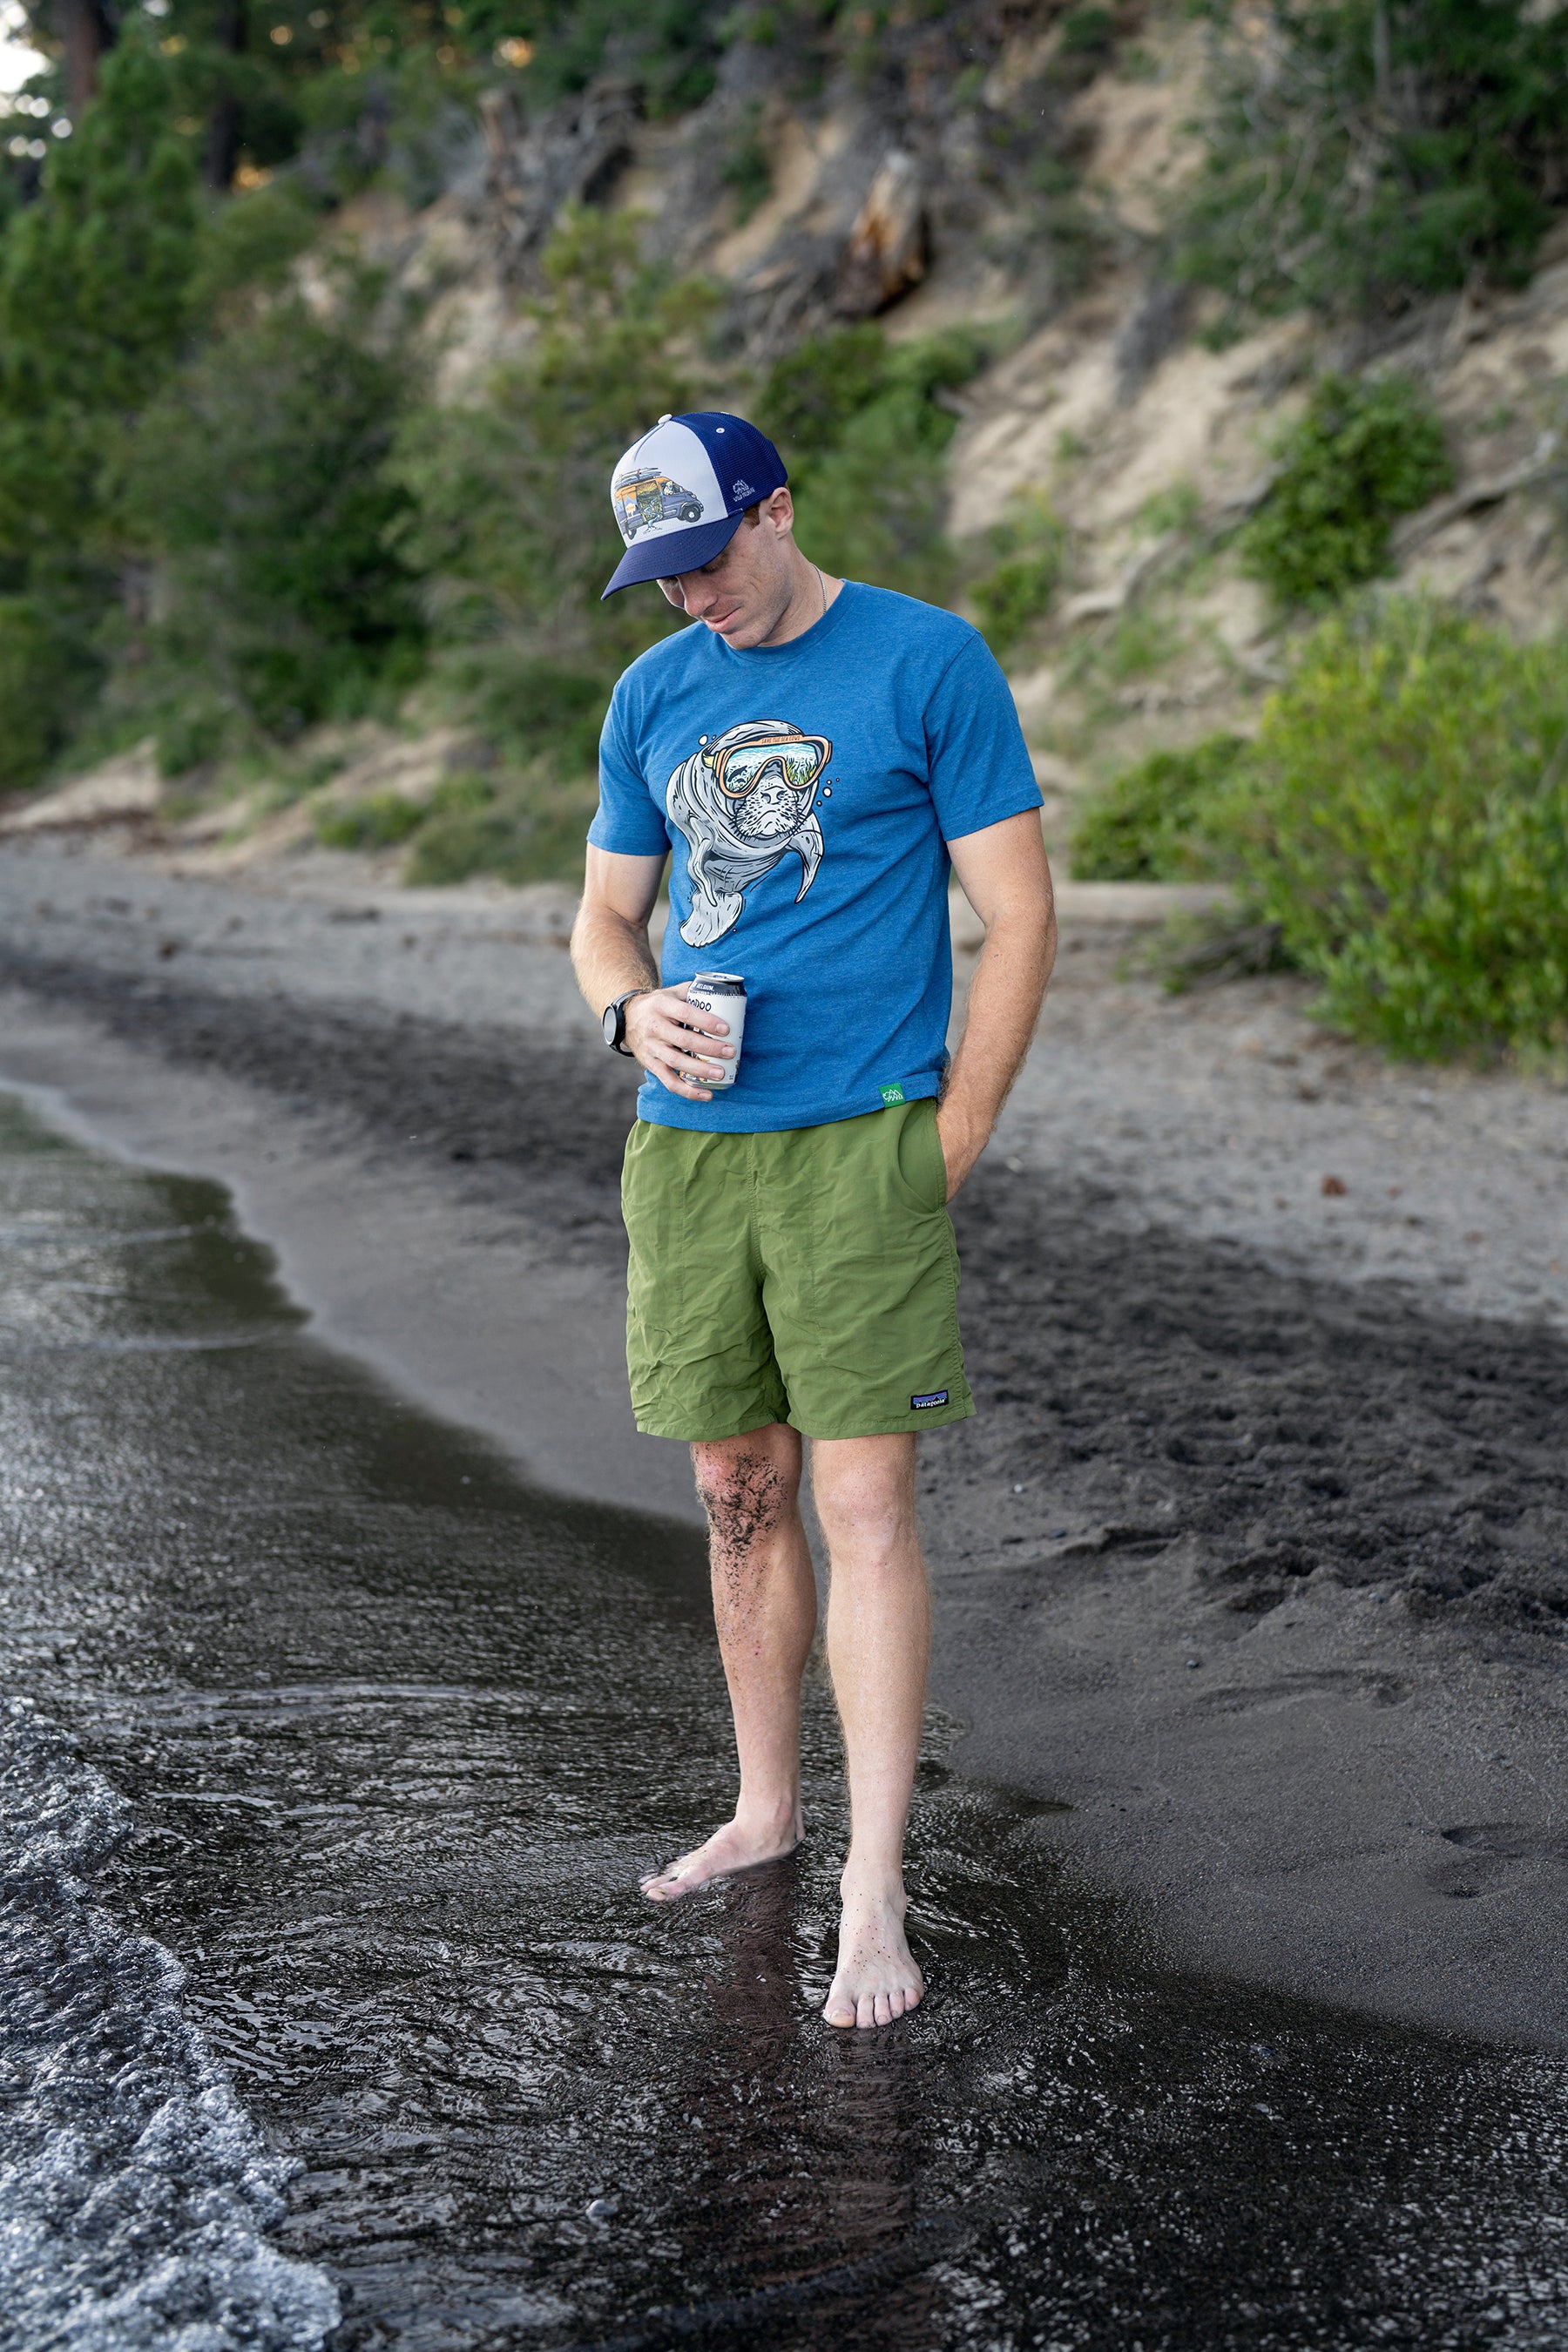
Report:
620,1101,976,1439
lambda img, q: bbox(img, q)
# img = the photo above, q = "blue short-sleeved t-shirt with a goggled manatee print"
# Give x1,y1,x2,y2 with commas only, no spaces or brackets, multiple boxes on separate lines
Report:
588,581,1039,1133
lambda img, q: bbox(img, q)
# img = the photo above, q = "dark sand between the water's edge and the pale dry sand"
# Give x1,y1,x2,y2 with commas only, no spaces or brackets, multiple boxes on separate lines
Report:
0,832,1568,2049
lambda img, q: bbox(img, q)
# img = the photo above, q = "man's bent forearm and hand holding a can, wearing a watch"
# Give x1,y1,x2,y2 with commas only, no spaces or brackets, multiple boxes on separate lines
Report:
571,844,736,1103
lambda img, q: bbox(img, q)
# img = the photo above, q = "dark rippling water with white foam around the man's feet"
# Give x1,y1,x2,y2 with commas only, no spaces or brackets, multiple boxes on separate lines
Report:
0,1103,1568,2352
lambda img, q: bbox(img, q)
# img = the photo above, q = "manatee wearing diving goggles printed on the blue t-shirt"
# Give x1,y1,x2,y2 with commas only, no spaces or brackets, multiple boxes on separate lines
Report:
666,720,832,948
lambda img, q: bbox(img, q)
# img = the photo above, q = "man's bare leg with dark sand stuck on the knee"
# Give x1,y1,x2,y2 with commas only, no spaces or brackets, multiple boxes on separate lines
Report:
642,1421,815,1903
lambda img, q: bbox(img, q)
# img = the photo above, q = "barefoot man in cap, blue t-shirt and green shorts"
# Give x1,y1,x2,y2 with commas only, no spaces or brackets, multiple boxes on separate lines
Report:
571,412,1056,2025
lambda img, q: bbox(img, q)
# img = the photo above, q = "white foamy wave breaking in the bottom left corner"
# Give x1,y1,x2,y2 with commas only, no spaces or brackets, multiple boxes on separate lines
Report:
0,1700,339,2352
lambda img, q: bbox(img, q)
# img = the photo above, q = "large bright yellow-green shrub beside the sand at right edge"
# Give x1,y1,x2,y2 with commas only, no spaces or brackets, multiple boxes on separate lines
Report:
1204,598,1568,1056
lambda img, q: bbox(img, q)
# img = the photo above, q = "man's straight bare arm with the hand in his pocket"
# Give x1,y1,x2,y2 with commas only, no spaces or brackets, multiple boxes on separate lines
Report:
936,809,1056,1200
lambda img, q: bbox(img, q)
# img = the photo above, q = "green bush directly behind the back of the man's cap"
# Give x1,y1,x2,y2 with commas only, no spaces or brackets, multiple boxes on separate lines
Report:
757,327,987,602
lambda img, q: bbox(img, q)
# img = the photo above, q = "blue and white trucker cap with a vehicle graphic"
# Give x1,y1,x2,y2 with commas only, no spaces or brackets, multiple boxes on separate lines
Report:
599,409,790,602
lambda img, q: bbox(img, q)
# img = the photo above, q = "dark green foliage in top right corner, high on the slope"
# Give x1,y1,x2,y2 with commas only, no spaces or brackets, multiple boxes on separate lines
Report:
1178,0,1568,329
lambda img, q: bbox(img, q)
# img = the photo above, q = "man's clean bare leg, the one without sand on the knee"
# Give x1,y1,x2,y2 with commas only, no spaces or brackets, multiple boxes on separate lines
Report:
811,1435,931,2025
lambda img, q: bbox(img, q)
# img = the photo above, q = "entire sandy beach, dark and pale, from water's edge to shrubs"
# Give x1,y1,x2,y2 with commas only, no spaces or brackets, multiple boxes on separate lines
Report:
0,851,1568,2049
